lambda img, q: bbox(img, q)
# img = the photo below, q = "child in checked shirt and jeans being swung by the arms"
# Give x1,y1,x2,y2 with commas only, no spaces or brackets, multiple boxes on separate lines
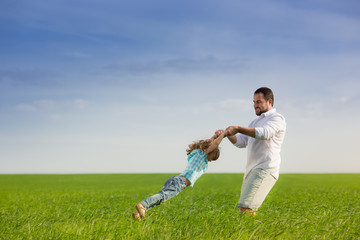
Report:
132,131,225,220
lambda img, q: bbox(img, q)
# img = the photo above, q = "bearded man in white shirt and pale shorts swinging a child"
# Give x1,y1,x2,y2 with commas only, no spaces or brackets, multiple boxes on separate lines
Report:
216,87,286,215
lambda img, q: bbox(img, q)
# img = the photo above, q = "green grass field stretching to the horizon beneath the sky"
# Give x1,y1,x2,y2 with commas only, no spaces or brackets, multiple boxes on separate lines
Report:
0,174,360,239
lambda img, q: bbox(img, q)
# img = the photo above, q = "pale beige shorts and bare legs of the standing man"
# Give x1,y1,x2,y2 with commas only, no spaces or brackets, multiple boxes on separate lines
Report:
238,168,276,216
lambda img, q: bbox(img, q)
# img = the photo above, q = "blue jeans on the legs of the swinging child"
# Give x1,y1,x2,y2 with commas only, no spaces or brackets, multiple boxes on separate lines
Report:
141,176,186,210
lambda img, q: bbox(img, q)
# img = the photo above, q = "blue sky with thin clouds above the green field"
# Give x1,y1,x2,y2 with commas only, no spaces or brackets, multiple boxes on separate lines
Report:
0,0,360,173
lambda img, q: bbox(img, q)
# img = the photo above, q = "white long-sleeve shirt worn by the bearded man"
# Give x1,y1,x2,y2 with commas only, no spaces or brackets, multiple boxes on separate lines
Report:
234,108,286,179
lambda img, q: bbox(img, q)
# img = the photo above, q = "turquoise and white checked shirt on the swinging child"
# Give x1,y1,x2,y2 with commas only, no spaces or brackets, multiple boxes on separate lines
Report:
180,149,208,187
